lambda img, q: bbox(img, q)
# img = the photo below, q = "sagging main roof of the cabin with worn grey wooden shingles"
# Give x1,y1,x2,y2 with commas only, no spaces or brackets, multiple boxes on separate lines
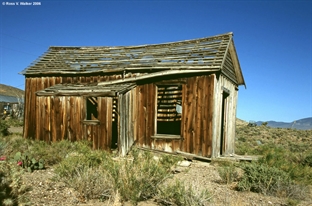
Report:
21,32,245,85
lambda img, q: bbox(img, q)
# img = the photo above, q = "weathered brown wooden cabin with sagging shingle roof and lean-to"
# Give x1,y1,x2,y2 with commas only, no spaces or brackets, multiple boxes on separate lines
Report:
21,33,245,158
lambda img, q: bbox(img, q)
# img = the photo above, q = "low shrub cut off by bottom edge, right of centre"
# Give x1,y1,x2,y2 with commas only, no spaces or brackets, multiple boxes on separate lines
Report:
156,181,211,206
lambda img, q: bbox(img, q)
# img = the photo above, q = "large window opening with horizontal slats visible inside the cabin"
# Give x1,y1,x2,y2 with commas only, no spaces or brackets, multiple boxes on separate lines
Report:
157,85,182,135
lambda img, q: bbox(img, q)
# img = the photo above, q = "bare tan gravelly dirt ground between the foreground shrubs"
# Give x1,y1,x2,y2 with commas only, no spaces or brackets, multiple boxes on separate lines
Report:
18,161,312,206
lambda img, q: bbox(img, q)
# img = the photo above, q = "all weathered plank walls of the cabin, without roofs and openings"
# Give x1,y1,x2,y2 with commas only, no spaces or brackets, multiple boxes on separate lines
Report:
24,74,237,157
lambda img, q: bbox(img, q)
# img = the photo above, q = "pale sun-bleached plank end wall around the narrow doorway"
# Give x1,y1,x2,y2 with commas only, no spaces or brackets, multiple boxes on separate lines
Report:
212,75,237,157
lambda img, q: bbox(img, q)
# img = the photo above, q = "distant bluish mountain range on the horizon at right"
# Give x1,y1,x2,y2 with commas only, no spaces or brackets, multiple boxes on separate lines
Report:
256,117,312,130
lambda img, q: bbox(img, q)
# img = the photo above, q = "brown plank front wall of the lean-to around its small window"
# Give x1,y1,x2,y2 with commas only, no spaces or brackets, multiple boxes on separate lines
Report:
35,96,112,150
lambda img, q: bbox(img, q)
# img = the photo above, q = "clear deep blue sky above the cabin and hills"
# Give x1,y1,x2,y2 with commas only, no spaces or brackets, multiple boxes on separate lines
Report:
0,0,312,122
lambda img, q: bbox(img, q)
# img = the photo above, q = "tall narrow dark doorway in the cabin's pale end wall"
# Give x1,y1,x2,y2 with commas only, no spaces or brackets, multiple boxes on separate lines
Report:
220,90,229,156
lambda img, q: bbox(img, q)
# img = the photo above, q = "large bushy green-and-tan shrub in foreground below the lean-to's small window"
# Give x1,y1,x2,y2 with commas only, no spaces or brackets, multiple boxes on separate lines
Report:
54,147,115,200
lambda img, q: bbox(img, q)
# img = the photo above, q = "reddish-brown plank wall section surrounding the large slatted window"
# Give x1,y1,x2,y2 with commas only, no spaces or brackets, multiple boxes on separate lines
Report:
129,74,215,157
